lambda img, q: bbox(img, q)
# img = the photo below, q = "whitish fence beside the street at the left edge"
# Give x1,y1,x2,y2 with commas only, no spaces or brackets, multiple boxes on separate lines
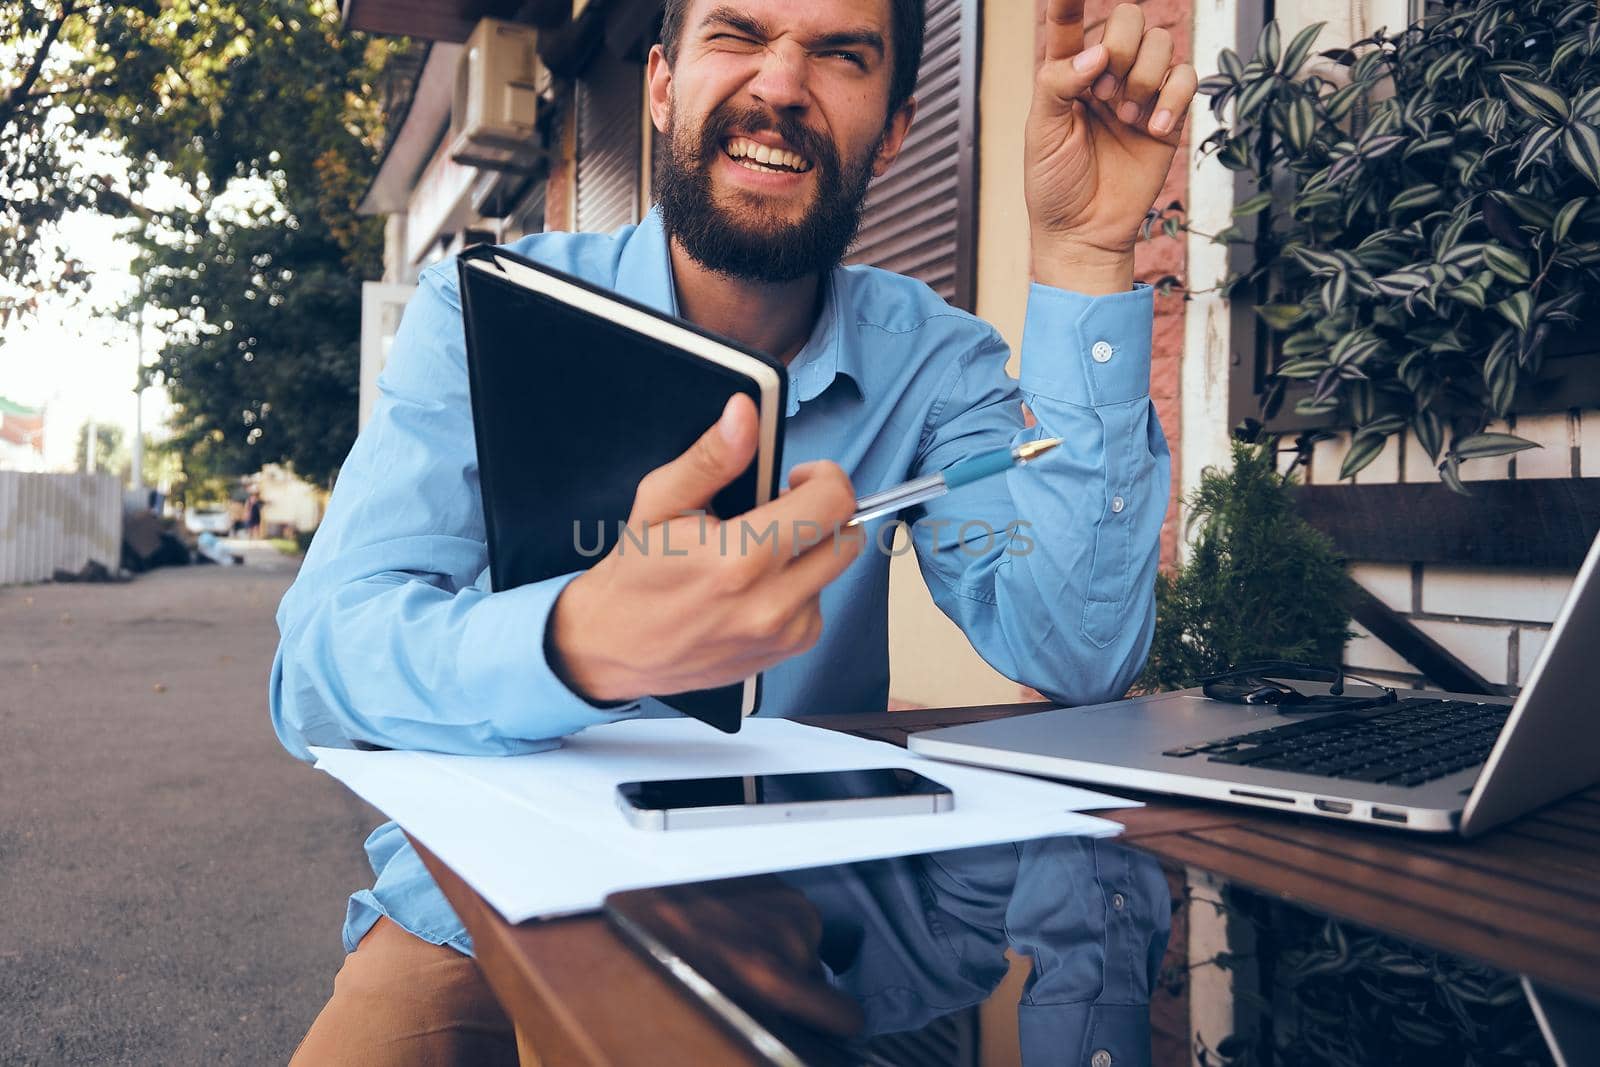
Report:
0,470,122,585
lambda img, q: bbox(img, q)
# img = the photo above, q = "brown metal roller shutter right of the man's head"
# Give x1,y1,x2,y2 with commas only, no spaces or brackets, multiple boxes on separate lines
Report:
848,0,979,310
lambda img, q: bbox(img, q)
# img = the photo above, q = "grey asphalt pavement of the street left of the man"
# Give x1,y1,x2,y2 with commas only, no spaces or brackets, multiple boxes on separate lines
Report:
0,545,379,1067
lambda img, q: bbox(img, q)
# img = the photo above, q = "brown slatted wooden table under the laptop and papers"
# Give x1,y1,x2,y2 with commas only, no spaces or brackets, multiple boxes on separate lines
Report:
418,704,1600,1064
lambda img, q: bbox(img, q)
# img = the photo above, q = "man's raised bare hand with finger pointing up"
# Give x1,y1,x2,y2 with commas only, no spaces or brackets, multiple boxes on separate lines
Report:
1022,0,1198,293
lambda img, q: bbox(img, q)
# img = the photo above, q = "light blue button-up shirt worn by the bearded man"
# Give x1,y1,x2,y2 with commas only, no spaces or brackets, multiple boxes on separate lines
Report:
270,213,1170,952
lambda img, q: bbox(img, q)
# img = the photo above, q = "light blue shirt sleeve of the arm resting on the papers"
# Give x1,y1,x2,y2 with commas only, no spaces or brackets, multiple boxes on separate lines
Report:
269,269,637,758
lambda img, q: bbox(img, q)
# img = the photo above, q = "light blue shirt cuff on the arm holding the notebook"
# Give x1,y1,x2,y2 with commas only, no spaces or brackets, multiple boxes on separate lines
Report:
461,574,638,737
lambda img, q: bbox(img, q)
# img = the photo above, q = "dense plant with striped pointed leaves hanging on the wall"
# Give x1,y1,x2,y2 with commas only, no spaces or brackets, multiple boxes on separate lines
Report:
1202,0,1600,491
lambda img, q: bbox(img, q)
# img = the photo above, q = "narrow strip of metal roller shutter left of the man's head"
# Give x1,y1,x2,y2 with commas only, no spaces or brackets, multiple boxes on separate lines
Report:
578,53,645,232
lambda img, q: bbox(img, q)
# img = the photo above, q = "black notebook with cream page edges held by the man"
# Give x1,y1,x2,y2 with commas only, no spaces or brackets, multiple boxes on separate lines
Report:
458,246,789,733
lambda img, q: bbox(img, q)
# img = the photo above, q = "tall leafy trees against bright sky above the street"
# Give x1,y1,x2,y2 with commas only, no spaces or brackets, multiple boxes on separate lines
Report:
0,0,398,482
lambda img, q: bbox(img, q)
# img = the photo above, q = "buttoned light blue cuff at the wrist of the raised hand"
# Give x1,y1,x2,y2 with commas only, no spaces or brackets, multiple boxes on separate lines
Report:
1021,282,1155,408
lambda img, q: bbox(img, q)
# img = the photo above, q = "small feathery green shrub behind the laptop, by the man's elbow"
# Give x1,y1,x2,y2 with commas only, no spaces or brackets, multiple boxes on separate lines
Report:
1139,438,1350,691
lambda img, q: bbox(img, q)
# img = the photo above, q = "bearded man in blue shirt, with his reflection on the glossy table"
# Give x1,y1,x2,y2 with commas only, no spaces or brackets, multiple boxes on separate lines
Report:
270,0,1195,1064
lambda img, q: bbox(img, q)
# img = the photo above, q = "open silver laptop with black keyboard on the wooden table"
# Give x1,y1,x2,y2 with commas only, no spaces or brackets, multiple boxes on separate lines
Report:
910,537,1600,837
